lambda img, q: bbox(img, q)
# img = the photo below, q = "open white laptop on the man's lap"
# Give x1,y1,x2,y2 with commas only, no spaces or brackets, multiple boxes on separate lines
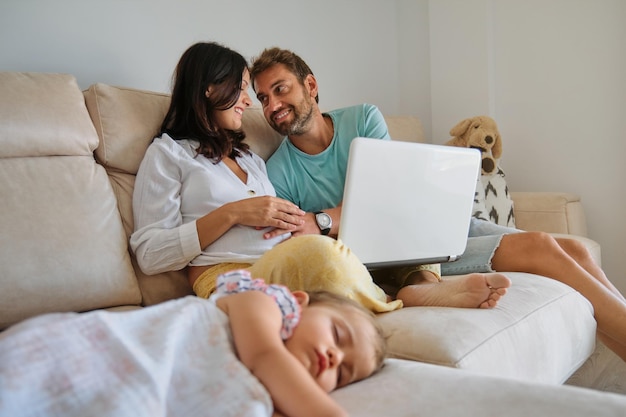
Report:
338,138,480,269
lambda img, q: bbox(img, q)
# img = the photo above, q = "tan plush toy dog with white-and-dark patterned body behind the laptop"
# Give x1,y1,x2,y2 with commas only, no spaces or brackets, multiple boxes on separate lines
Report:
446,116,515,227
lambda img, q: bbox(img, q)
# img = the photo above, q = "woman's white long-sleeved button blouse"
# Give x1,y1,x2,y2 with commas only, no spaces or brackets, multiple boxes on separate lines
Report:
130,134,289,274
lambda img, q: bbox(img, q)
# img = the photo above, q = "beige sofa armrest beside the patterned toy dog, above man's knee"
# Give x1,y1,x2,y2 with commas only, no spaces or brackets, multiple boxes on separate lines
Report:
511,192,587,236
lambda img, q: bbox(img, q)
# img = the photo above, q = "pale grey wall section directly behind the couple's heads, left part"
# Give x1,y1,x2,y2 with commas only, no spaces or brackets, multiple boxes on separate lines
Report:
0,0,398,113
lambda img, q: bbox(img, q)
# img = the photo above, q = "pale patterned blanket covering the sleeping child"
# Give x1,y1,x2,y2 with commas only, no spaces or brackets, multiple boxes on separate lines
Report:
0,296,273,417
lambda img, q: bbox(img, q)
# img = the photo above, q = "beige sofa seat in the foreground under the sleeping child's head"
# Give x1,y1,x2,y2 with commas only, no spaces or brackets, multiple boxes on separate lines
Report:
331,358,626,417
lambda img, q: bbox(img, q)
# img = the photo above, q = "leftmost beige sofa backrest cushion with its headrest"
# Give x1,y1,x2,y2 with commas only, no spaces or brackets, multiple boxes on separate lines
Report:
0,72,141,328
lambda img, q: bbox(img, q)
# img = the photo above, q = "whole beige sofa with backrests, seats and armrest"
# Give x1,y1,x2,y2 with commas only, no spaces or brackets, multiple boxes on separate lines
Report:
0,72,626,416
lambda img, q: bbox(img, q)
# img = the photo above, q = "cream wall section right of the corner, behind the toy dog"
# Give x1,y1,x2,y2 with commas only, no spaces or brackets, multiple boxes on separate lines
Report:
429,0,626,292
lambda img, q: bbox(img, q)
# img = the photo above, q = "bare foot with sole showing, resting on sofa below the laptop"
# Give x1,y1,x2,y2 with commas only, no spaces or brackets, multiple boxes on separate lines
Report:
397,273,511,308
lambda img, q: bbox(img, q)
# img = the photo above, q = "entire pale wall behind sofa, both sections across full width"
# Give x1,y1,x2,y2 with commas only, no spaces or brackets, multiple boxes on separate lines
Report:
0,0,626,291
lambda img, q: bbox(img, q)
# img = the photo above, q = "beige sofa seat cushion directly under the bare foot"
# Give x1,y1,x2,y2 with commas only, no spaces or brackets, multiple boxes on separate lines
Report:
379,273,596,384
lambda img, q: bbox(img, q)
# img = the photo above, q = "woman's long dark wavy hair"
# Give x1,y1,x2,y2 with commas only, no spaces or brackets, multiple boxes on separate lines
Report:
161,42,249,163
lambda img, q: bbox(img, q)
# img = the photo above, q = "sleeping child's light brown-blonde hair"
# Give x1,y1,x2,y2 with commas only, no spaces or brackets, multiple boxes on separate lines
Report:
307,291,387,371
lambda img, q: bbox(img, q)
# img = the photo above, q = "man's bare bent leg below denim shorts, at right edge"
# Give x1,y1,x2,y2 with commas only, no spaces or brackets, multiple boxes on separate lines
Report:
492,232,626,360
